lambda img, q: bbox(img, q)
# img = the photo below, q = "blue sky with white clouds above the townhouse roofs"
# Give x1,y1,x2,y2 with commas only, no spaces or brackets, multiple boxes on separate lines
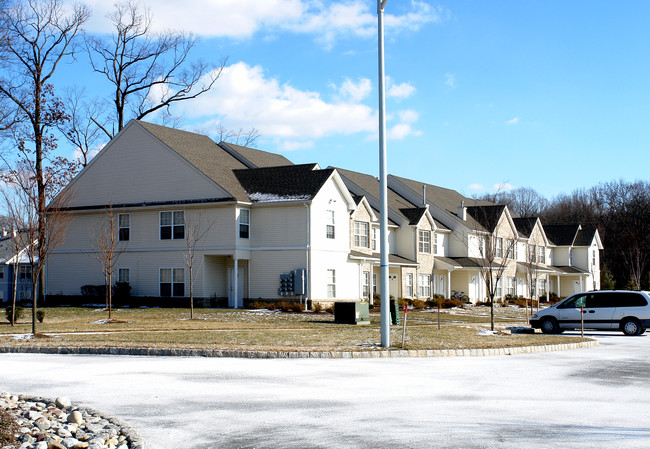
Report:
57,0,650,198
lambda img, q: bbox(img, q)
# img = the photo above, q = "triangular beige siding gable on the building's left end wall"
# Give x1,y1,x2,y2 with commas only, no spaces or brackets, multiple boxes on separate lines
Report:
63,121,225,207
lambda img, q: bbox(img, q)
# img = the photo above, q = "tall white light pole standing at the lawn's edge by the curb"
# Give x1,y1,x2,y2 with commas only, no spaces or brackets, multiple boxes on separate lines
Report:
377,0,390,348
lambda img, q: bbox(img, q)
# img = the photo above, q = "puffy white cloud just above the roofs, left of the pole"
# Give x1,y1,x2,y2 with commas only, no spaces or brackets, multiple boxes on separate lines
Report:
176,62,422,144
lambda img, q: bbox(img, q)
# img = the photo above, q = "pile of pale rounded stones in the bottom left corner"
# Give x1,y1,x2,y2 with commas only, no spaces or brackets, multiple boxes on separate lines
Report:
0,392,144,449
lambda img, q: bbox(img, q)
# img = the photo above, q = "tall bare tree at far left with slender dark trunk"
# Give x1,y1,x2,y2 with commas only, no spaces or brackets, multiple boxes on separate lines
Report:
0,0,90,308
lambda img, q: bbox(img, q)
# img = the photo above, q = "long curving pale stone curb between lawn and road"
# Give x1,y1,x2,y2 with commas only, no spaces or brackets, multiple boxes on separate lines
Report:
0,340,599,359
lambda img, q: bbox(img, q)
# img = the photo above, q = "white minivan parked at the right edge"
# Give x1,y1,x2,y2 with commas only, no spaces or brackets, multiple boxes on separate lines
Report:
530,290,650,335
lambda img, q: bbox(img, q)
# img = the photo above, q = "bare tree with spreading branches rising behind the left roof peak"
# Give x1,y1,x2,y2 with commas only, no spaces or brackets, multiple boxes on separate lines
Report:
87,0,225,138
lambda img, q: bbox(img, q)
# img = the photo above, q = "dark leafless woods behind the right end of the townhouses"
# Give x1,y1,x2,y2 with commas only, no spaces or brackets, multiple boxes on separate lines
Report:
482,180,650,290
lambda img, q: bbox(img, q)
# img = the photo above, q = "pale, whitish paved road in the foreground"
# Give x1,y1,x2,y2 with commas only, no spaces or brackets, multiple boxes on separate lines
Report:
0,334,650,449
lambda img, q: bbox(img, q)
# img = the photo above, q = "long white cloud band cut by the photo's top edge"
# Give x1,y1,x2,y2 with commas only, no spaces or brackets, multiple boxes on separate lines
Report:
74,0,445,47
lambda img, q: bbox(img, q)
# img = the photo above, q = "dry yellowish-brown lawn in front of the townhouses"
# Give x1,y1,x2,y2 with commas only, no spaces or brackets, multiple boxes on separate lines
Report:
0,307,586,351
